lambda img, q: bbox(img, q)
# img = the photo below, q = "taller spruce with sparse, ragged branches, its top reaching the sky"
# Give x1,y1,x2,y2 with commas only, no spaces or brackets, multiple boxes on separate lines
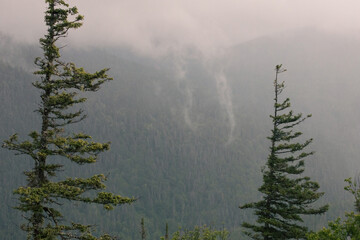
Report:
3,0,135,240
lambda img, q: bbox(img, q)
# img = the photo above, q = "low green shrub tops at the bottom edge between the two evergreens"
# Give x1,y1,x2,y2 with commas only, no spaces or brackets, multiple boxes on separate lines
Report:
160,226,229,240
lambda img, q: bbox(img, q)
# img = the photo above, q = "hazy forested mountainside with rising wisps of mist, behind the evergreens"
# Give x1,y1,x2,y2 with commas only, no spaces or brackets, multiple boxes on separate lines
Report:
0,30,360,239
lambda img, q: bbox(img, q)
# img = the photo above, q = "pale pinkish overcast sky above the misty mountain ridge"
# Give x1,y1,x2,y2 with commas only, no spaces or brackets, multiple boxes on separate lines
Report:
0,0,360,56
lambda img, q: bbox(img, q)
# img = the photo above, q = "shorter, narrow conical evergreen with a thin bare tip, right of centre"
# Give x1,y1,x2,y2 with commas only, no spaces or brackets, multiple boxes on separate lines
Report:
240,65,328,240
